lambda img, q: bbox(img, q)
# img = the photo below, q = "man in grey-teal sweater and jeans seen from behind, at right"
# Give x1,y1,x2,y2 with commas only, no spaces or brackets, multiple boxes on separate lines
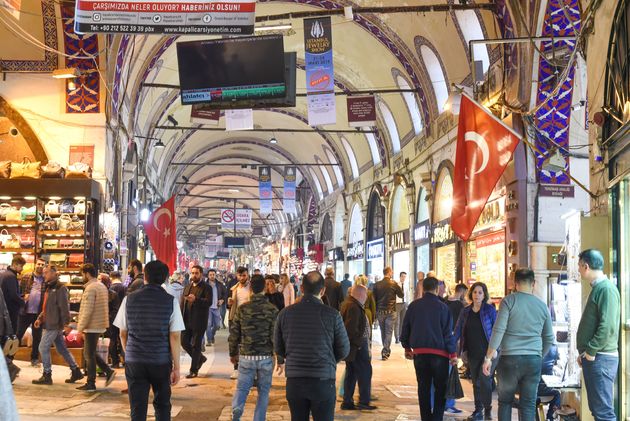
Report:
483,268,554,421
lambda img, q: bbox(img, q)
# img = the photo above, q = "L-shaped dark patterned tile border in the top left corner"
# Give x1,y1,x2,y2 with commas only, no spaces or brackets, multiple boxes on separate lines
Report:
0,1,59,73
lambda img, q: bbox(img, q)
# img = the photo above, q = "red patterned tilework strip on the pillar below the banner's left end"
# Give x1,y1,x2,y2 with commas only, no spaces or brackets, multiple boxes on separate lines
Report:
61,4,100,114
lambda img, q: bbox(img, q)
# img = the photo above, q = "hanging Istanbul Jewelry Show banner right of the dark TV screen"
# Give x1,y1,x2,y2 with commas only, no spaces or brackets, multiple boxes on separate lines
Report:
304,16,337,126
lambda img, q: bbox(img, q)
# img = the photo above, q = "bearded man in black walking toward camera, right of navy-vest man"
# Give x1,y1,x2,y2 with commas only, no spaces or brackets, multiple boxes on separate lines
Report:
182,265,212,379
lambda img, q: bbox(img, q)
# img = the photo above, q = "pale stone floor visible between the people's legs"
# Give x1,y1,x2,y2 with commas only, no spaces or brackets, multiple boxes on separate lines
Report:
14,330,508,421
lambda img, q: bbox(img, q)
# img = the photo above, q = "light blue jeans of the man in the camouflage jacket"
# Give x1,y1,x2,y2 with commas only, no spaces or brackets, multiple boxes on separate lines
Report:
232,357,273,421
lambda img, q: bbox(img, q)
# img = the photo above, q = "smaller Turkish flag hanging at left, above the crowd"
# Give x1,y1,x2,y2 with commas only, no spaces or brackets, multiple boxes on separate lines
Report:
142,196,177,273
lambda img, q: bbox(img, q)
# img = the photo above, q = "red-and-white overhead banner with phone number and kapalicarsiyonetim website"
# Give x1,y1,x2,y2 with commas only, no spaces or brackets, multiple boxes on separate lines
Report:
74,0,256,35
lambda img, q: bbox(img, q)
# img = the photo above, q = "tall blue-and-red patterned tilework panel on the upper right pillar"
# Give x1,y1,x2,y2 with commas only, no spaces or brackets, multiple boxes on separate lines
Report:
535,0,581,184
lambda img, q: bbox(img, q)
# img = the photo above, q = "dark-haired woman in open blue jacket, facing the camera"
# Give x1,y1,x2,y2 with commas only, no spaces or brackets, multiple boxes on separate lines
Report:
454,282,497,420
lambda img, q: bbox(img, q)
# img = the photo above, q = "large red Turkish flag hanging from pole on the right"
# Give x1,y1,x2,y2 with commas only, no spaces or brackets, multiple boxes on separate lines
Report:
451,95,521,241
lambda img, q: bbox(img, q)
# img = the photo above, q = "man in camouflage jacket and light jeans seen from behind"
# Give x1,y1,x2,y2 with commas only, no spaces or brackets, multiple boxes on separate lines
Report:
228,275,276,421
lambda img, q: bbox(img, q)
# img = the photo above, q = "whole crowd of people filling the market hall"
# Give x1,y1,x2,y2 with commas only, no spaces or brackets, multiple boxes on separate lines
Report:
0,246,620,421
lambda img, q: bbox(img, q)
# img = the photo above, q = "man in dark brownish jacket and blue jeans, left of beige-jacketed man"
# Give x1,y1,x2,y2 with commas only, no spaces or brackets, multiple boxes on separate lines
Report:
33,265,83,386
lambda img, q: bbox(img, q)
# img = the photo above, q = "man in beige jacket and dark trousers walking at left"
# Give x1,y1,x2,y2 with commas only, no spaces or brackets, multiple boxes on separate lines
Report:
77,263,116,392
